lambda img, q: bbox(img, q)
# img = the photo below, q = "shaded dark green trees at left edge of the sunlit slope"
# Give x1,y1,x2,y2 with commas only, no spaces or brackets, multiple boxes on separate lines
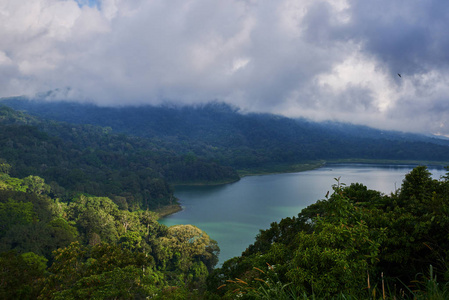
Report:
0,175,78,259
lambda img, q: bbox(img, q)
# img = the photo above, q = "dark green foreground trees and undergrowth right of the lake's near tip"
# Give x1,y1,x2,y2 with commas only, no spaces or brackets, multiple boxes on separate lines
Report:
208,167,449,299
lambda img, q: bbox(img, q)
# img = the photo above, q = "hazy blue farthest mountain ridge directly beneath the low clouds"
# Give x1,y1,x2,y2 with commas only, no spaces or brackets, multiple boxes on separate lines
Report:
2,98,449,171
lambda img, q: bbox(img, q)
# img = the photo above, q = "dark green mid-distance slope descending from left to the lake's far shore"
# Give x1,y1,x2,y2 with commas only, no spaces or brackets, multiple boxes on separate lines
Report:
0,107,238,210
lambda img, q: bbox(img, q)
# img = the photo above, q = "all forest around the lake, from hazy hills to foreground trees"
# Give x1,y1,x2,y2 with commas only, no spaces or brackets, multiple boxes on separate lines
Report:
0,102,449,299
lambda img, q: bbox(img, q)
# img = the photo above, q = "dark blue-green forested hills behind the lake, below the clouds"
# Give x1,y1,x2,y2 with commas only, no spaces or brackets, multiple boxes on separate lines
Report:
0,99,449,210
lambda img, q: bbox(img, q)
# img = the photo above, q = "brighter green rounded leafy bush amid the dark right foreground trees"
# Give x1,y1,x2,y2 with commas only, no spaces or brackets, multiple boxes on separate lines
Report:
287,219,379,298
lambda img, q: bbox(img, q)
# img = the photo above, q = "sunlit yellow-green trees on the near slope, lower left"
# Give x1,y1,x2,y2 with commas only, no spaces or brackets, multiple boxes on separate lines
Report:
0,170,219,300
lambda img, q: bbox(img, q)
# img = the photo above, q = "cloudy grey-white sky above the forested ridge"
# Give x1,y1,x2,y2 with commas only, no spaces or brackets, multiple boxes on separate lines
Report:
0,0,449,136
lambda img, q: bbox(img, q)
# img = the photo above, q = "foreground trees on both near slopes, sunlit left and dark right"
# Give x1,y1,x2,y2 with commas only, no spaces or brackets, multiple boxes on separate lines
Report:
0,163,449,299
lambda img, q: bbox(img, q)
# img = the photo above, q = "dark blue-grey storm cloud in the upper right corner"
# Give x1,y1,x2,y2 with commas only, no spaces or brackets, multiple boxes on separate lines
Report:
342,0,449,75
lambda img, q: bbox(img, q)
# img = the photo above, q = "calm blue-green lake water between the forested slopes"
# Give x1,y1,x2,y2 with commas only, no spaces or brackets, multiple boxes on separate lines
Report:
160,164,446,264
